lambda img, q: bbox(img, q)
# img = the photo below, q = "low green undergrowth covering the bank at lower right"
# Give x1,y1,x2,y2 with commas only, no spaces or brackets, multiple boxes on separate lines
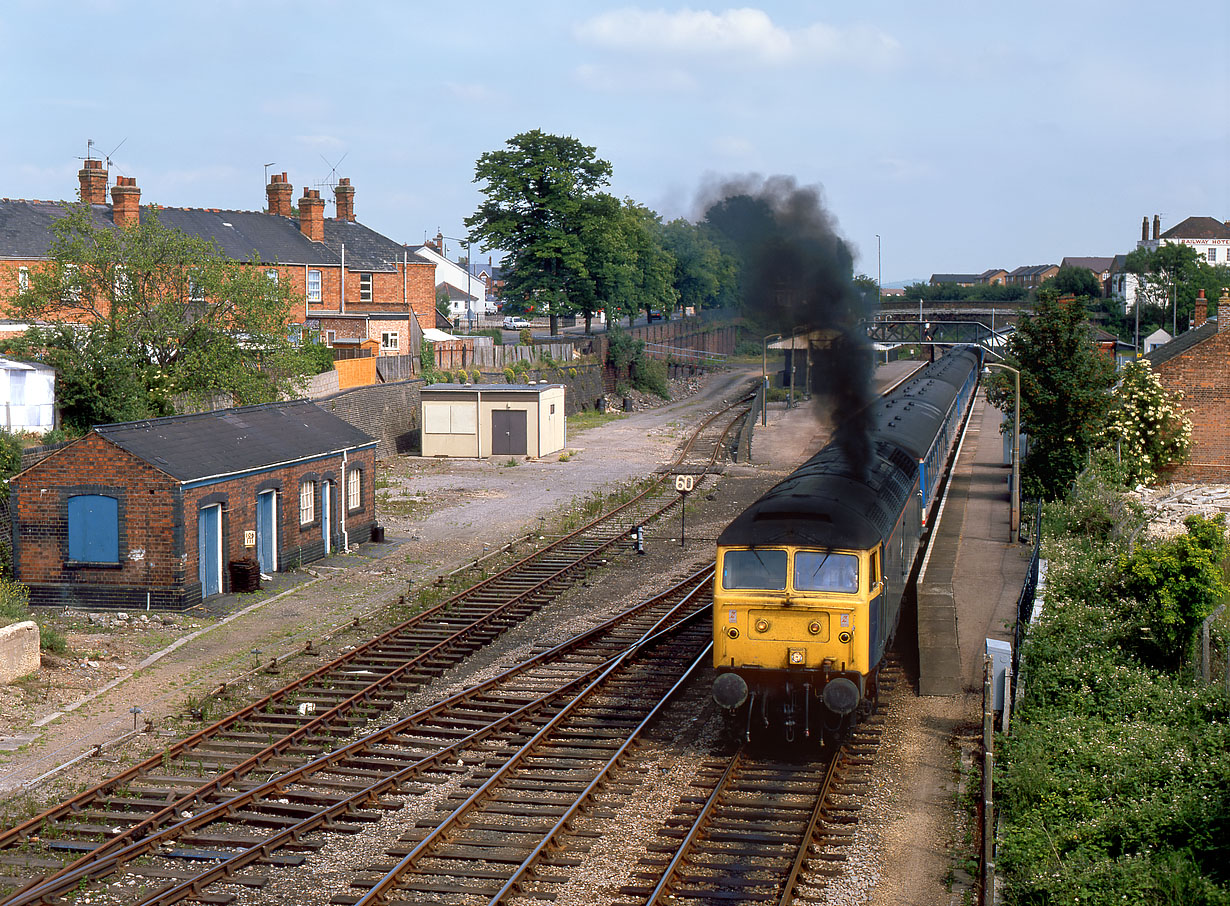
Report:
996,470,1230,906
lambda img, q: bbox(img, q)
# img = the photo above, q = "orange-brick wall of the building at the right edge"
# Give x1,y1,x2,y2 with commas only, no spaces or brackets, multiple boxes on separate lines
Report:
1154,328,1230,482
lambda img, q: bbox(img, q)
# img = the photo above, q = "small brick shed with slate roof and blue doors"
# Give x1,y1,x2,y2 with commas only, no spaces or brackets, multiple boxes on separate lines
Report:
9,401,376,610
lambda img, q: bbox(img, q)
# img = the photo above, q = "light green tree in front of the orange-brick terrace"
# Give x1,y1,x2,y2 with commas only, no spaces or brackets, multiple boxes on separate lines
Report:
4,205,315,430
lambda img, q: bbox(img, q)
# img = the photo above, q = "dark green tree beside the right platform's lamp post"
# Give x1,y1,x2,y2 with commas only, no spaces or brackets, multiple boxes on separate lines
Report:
986,289,1114,499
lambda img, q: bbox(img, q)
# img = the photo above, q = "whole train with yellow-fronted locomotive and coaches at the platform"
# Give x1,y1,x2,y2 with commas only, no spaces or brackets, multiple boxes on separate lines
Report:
712,347,982,741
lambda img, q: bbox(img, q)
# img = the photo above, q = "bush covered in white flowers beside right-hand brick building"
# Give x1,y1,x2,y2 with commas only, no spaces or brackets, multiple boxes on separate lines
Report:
1102,359,1192,484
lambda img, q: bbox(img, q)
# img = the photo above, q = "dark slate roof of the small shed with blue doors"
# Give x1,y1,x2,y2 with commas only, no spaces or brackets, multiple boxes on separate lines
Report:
93,400,376,482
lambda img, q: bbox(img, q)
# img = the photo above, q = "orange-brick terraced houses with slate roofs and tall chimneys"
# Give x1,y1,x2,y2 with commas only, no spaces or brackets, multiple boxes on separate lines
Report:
0,160,435,355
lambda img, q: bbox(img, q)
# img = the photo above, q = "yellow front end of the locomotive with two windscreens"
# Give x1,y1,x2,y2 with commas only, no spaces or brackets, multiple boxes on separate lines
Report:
713,546,884,735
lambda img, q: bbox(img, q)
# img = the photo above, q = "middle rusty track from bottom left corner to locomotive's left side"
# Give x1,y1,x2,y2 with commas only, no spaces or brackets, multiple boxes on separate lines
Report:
0,568,712,905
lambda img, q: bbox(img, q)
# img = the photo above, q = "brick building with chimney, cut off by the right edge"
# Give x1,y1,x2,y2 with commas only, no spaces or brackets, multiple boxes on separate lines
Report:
1145,289,1230,482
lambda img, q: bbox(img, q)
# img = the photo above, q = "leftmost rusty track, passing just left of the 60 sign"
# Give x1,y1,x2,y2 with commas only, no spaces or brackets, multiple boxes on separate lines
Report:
0,386,750,904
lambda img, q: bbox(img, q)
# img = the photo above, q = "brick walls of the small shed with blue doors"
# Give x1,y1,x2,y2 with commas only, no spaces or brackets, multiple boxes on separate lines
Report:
10,434,375,610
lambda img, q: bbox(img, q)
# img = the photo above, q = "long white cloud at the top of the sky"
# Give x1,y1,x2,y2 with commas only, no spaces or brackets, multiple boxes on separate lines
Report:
573,7,900,65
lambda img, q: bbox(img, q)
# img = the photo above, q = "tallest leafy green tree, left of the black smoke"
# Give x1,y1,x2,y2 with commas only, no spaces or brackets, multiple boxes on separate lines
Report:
465,129,617,333
